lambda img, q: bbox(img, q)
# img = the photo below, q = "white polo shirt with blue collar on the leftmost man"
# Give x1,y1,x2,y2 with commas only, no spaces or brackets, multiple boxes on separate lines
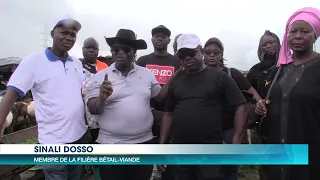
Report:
8,48,87,144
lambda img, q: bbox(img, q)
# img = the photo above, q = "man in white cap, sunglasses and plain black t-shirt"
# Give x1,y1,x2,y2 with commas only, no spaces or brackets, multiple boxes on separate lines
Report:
160,34,247,180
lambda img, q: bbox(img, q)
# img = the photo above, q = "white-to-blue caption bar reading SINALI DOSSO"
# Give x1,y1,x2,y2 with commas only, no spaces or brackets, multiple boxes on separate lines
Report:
0,144,292,155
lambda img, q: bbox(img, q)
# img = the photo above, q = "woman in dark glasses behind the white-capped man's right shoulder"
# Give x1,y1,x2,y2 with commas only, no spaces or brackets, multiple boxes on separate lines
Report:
203,38,261,180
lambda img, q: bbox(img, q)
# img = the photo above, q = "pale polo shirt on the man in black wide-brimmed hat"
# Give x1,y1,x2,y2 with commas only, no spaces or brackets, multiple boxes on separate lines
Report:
87,63,161,144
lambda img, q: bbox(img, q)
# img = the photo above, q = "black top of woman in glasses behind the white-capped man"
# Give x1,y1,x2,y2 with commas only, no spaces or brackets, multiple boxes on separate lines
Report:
222,67,251,130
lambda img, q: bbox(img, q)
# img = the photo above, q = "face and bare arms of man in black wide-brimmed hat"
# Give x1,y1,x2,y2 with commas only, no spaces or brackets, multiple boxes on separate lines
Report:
87,45,183,115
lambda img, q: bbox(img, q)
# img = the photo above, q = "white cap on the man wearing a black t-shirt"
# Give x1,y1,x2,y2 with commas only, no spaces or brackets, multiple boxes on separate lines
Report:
177,34,201,51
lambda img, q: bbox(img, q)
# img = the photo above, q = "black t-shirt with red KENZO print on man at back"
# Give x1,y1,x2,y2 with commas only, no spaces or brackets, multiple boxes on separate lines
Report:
136,53,181,111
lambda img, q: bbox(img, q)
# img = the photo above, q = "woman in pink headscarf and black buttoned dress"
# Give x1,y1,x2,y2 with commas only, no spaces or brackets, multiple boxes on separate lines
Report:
256,8,320,180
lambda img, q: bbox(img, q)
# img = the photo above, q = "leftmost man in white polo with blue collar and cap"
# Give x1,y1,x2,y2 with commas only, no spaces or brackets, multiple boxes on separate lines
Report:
0,17,89,180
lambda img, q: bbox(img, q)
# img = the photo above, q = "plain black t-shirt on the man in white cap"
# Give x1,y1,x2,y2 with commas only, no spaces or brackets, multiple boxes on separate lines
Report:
165,67,246,144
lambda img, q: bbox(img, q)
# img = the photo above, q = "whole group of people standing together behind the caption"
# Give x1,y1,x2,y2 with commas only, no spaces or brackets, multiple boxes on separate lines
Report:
0,8,320,180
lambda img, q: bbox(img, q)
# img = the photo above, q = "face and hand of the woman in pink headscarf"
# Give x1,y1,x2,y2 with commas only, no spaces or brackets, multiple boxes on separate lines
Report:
255,21,318,115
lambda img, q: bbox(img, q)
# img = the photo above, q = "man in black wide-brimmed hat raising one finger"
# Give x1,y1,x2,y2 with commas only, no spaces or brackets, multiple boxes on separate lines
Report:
87,29,174,180
